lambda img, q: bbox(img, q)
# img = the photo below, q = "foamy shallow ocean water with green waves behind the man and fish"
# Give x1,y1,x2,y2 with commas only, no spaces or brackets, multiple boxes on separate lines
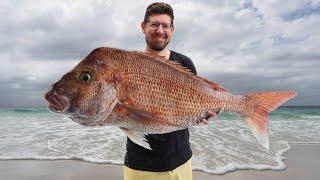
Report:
0,107,320,174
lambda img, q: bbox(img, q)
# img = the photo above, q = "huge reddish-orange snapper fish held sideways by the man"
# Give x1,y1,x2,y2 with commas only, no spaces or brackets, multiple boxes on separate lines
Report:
45,47,296,149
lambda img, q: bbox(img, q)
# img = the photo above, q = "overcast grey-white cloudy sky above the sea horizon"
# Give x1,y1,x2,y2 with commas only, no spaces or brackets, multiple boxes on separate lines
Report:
0,0,320,107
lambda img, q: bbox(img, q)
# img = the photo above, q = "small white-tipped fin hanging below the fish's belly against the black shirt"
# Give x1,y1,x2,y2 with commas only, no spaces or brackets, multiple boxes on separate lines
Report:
120,128,152,150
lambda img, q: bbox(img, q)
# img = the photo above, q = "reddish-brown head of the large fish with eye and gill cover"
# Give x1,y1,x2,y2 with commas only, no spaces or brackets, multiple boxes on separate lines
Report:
45,47,117,126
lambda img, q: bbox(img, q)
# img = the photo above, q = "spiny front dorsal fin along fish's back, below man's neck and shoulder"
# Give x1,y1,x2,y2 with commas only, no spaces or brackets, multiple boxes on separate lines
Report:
134,51,195,75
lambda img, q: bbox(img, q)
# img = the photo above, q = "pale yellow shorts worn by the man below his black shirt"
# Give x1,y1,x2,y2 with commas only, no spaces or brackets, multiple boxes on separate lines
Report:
123,159,192,180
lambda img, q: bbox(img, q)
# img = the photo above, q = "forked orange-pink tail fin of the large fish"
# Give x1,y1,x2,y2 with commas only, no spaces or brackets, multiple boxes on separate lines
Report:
242,91,297,149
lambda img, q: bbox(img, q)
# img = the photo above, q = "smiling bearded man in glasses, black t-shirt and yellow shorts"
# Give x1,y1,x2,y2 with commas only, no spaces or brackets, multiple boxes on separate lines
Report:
124,3,215,180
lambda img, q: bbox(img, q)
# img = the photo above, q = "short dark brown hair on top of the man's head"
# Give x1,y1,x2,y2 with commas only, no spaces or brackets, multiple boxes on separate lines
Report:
143,2,174,26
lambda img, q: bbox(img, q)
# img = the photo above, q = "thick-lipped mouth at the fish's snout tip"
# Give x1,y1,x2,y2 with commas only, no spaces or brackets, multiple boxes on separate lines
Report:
45,91,69,113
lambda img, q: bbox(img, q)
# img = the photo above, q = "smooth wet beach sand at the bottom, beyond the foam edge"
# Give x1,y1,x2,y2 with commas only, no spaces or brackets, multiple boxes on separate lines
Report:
0,144,320,180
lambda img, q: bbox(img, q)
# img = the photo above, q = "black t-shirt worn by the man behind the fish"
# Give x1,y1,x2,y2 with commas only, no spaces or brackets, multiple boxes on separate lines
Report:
124,51,197,172
